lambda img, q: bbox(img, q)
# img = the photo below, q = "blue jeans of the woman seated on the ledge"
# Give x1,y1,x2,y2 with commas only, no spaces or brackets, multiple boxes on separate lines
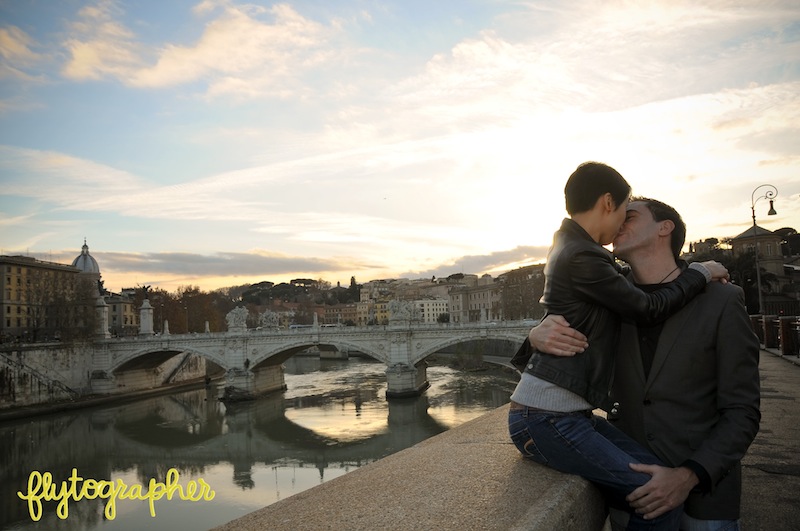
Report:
508,408,683,531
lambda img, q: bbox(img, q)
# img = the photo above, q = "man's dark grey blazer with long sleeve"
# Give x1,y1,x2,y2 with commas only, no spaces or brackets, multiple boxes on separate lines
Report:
609,282,761,520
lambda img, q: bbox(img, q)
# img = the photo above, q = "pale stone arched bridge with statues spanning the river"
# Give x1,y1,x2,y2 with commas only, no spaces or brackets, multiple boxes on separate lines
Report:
91,321,531,398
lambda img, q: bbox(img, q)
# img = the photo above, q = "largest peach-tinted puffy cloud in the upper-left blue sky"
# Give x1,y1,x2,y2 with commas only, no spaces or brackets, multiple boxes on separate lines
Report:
63,1,346,99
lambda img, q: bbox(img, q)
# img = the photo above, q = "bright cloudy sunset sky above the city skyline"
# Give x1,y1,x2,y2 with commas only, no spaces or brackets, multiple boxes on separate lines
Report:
0,0,800,291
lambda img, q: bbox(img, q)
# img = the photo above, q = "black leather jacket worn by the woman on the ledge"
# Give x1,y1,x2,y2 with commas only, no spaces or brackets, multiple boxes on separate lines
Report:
514,218,706,411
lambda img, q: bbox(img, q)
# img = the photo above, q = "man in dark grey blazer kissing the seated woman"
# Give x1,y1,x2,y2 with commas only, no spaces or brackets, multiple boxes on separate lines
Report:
530,199,760,531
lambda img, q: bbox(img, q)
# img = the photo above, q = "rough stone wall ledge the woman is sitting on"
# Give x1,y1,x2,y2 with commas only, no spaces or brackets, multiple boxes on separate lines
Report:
216,406,605,531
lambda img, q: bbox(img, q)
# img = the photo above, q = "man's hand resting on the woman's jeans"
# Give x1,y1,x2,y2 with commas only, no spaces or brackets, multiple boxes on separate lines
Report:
625,463,700,520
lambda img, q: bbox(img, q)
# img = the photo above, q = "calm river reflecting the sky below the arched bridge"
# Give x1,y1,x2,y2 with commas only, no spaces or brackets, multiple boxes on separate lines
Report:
0,356,517,531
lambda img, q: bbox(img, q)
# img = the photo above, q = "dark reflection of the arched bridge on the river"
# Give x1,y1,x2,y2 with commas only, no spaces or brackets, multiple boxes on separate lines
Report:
113,393,454,475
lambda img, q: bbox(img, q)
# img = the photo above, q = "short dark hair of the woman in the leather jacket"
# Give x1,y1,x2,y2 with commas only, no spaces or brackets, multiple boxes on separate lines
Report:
564,162,631,216
